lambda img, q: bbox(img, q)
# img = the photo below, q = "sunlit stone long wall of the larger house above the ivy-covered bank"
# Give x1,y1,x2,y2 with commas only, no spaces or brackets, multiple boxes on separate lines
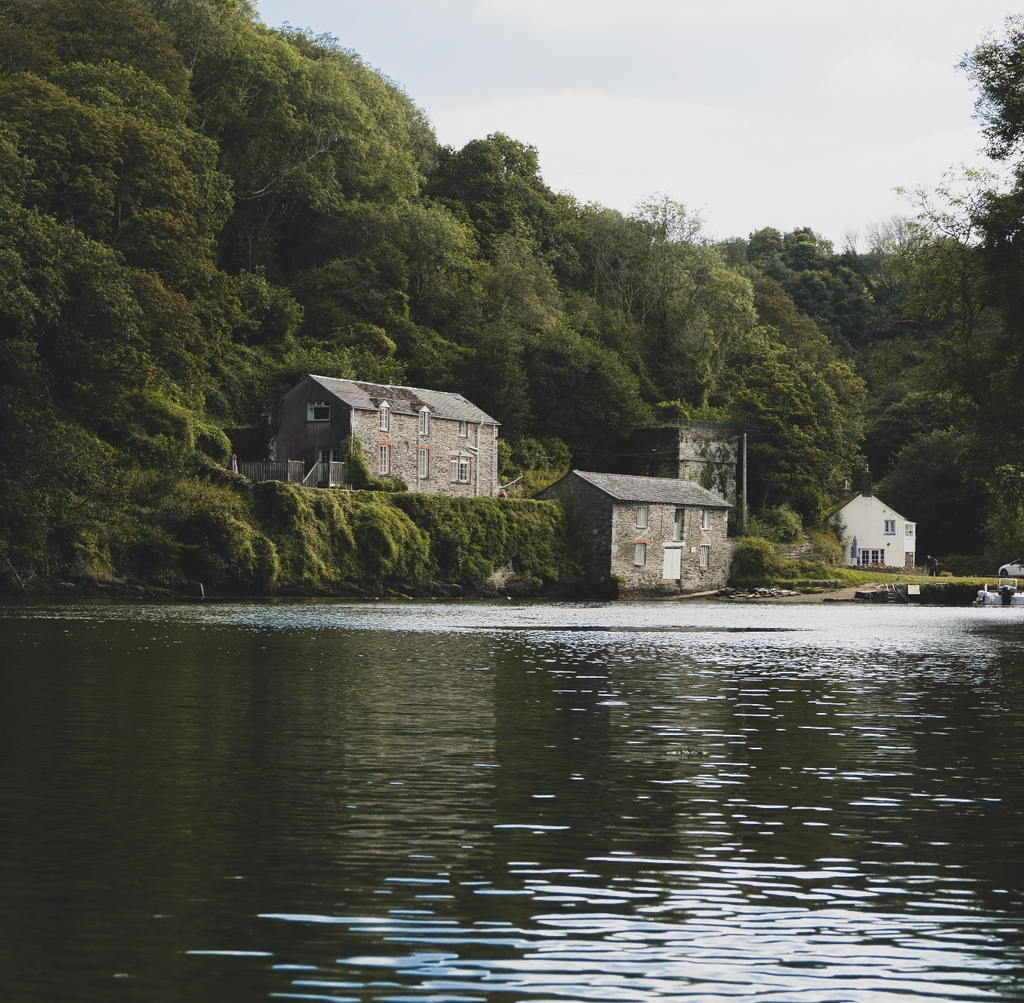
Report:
354,411,498,498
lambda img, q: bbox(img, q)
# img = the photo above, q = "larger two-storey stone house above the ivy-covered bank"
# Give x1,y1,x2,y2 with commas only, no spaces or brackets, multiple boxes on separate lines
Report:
273,374,499,497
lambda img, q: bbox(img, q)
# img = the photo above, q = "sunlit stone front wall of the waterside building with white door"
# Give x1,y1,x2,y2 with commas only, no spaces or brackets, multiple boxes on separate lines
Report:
610,504,732,594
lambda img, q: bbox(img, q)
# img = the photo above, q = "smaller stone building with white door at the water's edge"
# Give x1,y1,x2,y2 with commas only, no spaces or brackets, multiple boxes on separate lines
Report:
537,470,732,594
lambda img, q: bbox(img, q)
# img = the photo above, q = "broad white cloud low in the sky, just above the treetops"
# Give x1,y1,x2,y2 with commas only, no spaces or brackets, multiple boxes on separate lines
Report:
435,91,995,243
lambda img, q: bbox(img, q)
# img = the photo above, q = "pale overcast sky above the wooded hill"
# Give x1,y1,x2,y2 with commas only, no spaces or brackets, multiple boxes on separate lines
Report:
251,0,1015,249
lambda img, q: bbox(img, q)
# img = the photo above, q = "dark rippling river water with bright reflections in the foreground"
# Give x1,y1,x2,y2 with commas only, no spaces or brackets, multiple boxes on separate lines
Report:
0,600,1024,1003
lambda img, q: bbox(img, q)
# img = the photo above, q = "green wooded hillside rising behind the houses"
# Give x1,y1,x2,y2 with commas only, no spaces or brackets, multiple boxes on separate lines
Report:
0,0,1024,578
